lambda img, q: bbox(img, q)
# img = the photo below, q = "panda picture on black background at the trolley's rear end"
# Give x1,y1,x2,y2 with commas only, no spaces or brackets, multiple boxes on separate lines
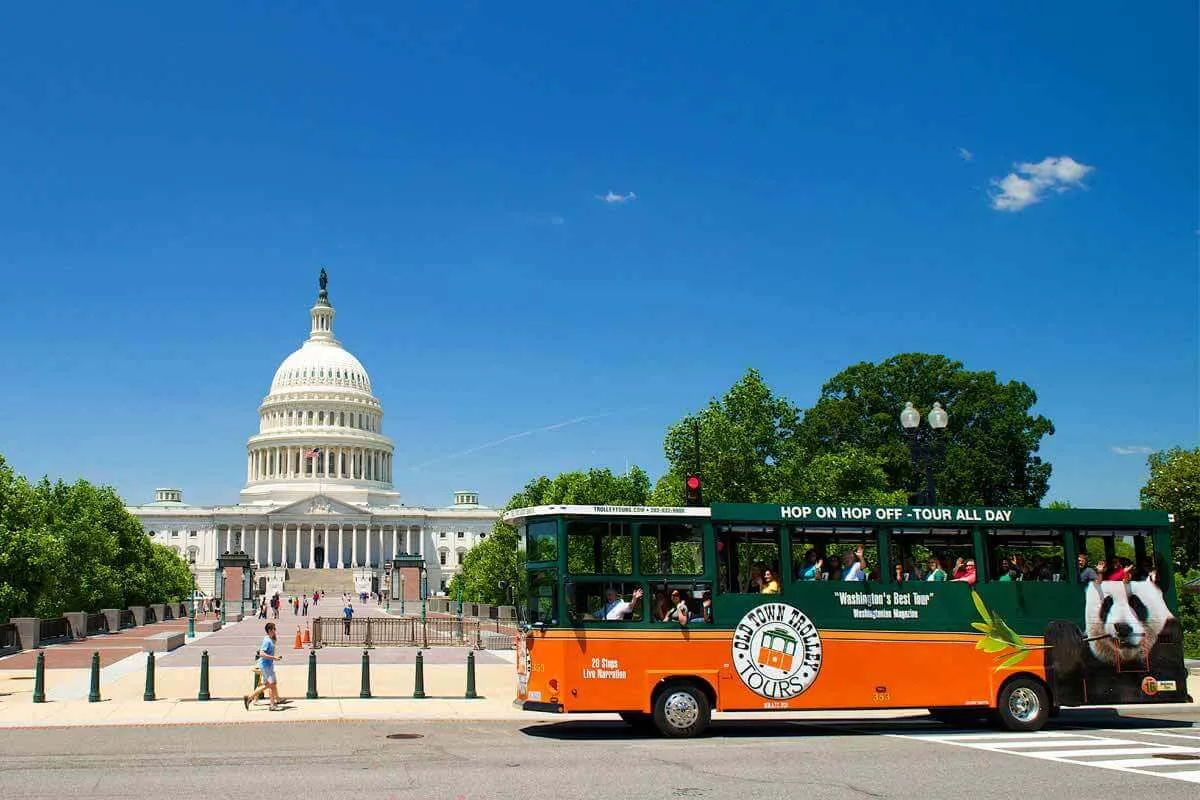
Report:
1045,570,1187,705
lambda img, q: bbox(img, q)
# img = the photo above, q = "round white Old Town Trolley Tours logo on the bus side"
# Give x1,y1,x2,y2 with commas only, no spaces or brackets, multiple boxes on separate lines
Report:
733,603,821,700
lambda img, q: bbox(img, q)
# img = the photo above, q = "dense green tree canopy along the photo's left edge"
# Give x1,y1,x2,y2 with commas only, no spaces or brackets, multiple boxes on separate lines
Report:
0,456,192,620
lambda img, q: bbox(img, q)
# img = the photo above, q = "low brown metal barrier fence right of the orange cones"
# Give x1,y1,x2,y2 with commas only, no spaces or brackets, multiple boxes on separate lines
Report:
312,616,517,650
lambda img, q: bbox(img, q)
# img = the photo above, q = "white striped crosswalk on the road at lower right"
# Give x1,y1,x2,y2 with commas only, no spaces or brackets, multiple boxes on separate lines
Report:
892,728,1200,783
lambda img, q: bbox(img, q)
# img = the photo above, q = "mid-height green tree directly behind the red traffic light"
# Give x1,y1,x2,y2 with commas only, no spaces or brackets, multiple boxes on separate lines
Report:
652,369,800,506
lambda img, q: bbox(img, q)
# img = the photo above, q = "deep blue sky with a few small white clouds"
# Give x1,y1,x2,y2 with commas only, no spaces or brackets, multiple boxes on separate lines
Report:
0,1,1200,506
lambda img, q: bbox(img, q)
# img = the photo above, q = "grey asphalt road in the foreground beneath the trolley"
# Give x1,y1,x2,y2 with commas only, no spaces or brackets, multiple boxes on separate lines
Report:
0,712,1200,800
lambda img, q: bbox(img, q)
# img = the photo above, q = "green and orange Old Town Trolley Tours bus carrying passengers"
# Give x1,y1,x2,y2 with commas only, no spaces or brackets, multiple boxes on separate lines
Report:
504,504,1189,736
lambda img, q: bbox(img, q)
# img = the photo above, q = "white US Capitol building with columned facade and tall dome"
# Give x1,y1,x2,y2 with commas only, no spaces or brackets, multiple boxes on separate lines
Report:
128,270,499,595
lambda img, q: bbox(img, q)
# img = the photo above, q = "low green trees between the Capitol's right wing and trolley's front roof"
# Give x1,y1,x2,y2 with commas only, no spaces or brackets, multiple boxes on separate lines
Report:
446,467,650,604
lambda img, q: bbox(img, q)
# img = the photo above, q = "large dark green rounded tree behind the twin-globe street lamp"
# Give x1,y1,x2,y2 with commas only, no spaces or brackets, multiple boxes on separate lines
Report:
798,353,1054,506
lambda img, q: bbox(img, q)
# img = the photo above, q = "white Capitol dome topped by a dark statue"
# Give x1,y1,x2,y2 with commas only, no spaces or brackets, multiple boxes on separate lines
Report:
241,270,400,505
